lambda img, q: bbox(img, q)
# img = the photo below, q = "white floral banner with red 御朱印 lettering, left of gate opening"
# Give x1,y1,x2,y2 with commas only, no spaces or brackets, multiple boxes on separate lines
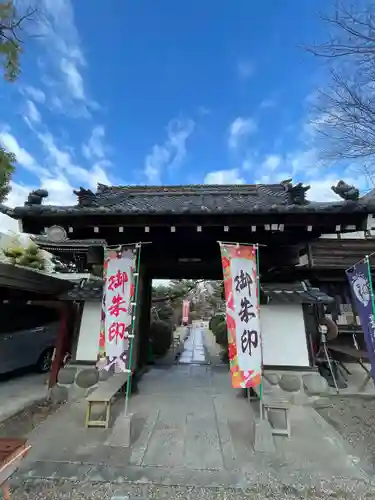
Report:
97,247,137,372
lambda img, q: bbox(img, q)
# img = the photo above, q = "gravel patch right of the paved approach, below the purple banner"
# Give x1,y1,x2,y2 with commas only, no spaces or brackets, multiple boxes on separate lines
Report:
317,396,375,471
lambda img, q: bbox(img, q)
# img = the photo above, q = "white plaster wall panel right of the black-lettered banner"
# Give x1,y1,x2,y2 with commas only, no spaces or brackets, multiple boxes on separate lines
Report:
260,304,310,366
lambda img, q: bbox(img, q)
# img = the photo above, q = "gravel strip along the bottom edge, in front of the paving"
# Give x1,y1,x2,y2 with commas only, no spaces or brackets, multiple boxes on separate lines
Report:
6,480,375,500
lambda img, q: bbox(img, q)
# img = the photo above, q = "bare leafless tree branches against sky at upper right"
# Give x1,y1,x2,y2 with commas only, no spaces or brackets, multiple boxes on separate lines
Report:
307,0,375,163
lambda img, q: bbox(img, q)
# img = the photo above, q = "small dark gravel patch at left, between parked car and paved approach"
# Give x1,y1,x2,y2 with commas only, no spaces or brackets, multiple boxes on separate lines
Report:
0,400,61,438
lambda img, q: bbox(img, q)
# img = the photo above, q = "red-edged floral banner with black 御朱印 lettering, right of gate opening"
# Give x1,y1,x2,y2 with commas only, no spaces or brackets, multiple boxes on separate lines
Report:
220,243,262,388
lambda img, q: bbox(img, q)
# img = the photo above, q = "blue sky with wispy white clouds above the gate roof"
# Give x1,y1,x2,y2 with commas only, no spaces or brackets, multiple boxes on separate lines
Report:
0,0,368,228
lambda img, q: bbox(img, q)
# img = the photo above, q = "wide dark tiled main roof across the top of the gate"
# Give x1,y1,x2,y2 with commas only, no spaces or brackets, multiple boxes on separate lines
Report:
0,181,375,219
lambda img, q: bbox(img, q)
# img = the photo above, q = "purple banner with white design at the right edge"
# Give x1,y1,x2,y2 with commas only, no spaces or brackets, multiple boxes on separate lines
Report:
345,260,375,381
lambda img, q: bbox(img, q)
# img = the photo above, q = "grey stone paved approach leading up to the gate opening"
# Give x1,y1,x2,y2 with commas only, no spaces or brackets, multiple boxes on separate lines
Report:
10,328,369,488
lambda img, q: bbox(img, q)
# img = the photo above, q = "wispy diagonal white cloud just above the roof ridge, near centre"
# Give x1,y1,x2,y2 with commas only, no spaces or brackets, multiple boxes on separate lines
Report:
144,120,195,184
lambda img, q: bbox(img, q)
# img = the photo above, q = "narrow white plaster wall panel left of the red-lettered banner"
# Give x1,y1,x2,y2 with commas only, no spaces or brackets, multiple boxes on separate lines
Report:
76,301,102,361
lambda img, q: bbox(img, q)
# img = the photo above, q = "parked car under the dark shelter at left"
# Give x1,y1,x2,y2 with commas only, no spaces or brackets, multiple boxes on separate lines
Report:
0,303,59,374
